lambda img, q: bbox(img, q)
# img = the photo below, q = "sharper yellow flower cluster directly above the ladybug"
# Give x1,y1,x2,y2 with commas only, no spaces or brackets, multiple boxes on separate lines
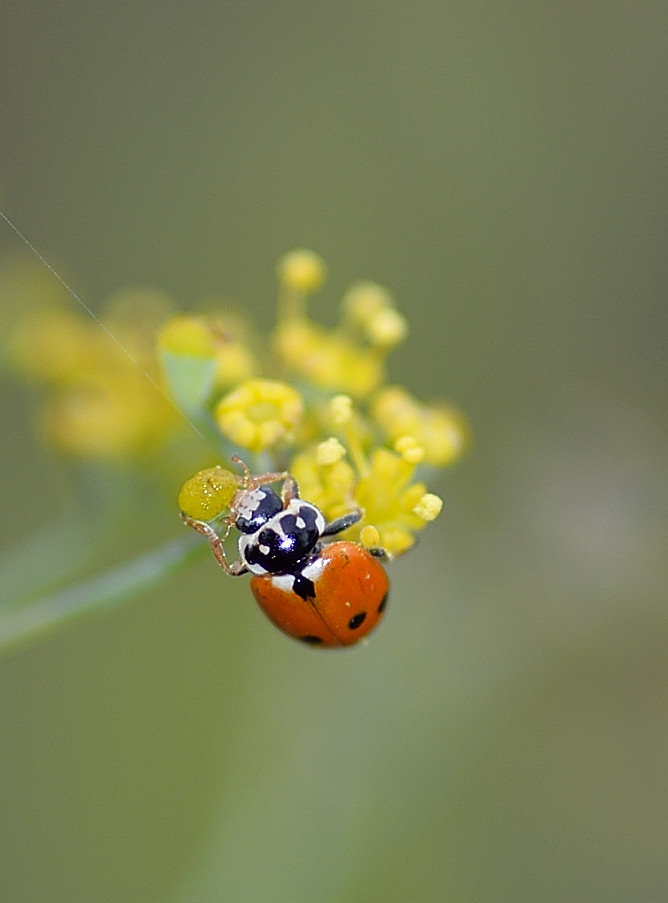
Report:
166,250,466,555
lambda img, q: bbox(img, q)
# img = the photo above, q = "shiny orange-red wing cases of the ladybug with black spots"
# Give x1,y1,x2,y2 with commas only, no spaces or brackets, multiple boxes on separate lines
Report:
250,540,390,646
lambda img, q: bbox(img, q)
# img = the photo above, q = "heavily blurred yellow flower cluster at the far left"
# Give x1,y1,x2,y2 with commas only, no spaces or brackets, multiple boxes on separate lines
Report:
0,262,178,460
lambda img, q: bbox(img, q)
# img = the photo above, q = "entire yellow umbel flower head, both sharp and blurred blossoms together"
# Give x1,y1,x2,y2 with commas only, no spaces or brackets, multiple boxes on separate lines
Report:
0,250,467,555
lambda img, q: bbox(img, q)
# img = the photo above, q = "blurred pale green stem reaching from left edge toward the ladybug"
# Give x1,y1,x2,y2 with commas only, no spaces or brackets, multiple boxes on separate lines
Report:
0,536,206,652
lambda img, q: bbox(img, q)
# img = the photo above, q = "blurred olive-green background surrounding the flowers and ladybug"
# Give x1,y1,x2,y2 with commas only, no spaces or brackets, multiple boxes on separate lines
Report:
0,0,668,903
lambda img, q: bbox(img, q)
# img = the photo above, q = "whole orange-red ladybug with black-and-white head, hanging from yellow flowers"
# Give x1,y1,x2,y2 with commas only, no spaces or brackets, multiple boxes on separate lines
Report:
181,457,390,646
